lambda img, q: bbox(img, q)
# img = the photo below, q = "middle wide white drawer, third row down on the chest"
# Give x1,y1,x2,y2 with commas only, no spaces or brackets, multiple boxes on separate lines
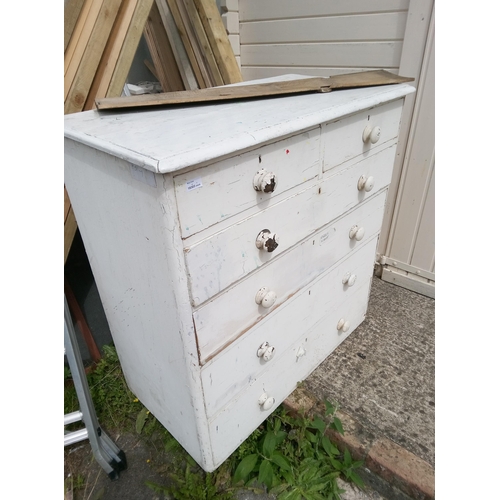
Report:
193,191,386,364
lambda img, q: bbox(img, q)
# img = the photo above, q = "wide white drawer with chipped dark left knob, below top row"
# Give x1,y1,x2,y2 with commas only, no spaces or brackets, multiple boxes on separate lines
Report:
185,145,396,307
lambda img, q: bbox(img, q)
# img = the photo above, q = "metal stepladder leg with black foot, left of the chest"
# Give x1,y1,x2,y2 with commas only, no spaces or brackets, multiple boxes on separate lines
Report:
64,297,127,479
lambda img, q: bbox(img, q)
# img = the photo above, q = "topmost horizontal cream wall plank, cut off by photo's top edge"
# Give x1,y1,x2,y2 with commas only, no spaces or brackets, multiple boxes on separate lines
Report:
239,0,409,22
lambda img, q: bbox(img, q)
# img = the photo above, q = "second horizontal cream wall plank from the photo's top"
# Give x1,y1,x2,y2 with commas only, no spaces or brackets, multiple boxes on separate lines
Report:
240,12,406,45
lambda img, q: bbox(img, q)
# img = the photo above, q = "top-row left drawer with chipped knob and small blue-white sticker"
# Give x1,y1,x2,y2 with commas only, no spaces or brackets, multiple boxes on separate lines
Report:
174,128,320,238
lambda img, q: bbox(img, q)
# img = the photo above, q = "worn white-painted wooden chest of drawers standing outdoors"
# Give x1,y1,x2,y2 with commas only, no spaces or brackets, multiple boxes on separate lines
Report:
65,79,413,471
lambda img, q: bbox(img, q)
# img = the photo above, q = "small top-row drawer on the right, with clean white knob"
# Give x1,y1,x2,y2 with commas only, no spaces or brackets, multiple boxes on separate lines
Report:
323,99,403,171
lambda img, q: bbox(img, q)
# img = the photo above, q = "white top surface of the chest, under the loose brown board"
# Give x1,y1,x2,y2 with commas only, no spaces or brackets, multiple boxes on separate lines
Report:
64,77,414,173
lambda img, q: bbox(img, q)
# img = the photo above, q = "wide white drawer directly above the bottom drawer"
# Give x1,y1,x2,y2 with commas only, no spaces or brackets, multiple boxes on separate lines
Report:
201,238,377,416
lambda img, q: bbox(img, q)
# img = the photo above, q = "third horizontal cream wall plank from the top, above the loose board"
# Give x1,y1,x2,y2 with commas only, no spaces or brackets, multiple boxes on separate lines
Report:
241,41,403,72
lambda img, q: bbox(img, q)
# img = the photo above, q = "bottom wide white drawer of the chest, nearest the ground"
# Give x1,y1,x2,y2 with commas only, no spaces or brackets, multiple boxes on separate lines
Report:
205,279,371,467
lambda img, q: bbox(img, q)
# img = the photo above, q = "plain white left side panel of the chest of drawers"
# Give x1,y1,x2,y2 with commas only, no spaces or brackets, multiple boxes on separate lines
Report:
64,140,211,463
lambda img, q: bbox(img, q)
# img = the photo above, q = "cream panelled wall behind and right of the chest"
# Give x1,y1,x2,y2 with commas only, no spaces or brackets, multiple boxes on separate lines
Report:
227,0,435,296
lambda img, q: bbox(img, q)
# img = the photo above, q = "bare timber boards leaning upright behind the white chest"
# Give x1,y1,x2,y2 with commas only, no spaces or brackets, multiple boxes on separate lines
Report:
64,0,243,262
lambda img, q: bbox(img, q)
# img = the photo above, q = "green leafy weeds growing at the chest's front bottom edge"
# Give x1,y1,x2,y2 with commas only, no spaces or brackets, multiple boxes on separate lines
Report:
233,401,364,500
